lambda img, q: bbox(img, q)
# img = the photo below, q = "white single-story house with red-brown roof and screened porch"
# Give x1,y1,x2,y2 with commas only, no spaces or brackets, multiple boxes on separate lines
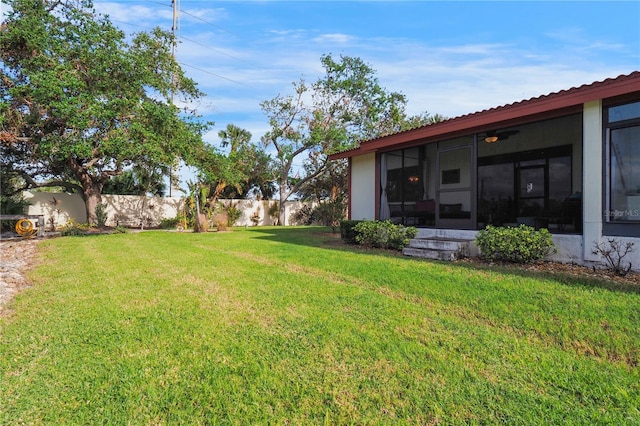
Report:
330,71,640,270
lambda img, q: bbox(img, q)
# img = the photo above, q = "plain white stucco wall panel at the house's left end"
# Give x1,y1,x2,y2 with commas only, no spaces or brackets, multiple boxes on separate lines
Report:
351,153,376,220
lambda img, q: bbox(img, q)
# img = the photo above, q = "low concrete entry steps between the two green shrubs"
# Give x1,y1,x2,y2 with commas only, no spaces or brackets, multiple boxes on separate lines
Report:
402,237,477,260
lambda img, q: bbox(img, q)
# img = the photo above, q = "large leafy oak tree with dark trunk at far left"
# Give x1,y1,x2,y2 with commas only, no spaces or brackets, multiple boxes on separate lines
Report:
0,0,208,222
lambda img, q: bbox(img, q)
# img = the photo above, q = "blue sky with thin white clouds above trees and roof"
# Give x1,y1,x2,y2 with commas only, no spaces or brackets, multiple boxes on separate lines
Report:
0,0,640,183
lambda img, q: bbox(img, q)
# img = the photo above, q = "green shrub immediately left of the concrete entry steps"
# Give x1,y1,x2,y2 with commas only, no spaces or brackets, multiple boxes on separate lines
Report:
354,220,418,250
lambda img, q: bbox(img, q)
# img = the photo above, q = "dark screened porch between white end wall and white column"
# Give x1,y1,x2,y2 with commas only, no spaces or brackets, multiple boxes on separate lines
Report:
379,114,582,233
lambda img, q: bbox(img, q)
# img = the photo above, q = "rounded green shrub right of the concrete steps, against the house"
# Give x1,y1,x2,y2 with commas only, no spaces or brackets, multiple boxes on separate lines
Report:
475,225,555,263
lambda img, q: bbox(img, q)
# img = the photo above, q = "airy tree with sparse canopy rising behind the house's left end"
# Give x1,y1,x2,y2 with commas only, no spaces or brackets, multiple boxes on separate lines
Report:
261,55,440,223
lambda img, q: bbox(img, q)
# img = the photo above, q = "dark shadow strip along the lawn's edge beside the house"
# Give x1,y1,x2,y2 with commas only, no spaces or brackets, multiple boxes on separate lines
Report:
249,227,640,294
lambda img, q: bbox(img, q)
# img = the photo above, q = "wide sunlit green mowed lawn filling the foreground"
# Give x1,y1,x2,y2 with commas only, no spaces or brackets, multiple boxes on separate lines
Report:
0,228,640,425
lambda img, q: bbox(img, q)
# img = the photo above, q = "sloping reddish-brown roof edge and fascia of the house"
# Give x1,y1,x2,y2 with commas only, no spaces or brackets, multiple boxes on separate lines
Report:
329,71,640,160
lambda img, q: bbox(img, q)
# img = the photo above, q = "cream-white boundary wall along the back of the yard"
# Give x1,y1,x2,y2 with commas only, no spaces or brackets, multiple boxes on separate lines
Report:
23,192,309,229
